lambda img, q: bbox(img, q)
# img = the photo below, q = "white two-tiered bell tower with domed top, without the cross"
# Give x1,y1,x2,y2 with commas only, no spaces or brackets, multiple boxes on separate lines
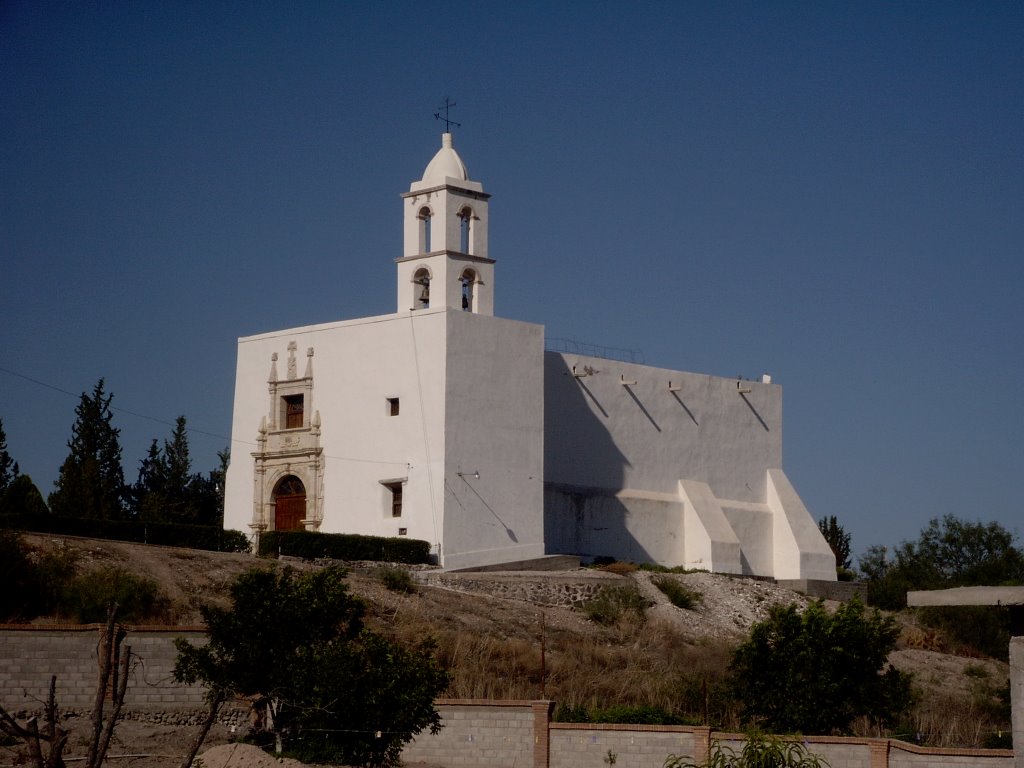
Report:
395,133,495,315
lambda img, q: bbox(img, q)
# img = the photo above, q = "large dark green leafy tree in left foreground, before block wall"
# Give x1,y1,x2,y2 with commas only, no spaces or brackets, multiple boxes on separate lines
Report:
174,567,449,766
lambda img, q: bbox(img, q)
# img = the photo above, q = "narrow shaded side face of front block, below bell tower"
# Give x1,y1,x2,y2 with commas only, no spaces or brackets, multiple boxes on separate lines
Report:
443,311,544,567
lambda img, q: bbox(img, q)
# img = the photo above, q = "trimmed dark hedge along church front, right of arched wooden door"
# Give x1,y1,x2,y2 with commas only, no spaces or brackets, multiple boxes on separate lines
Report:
259,530,430,564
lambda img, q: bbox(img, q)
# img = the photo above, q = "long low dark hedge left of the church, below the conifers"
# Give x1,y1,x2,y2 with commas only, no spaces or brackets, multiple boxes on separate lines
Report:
0,515,250,552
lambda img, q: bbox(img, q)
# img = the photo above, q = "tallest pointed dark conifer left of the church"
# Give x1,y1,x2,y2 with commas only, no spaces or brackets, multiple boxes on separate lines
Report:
49,379,126,520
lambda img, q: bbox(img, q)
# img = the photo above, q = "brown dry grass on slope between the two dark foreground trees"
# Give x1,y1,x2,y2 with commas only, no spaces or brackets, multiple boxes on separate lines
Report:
364,582,738,727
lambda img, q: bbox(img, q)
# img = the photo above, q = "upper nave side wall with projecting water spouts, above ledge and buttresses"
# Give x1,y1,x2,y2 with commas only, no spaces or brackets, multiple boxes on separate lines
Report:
545,352,782,503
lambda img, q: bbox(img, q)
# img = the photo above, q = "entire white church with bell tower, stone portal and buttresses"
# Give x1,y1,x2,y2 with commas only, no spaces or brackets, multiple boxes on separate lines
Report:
224,133,836,581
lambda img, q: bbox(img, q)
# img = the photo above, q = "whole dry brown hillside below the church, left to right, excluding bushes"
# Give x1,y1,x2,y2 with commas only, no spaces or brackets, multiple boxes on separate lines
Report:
16,536,1009,746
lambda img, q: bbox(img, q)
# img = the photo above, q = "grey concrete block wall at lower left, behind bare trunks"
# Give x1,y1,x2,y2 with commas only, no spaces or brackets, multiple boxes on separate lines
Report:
0,625,206,712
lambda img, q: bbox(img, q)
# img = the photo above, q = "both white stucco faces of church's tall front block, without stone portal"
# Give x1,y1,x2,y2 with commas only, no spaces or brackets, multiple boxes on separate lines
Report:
224,308,544,567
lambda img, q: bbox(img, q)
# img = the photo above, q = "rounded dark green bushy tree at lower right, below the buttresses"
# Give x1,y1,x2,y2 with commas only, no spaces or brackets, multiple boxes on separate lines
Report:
730,599,911,734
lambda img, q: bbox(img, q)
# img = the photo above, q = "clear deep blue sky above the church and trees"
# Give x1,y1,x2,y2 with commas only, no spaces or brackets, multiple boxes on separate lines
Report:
0,0,1024,551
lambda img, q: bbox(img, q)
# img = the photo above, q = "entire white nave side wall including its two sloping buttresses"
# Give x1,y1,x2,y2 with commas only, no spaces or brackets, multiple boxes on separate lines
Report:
545,352,836,581
